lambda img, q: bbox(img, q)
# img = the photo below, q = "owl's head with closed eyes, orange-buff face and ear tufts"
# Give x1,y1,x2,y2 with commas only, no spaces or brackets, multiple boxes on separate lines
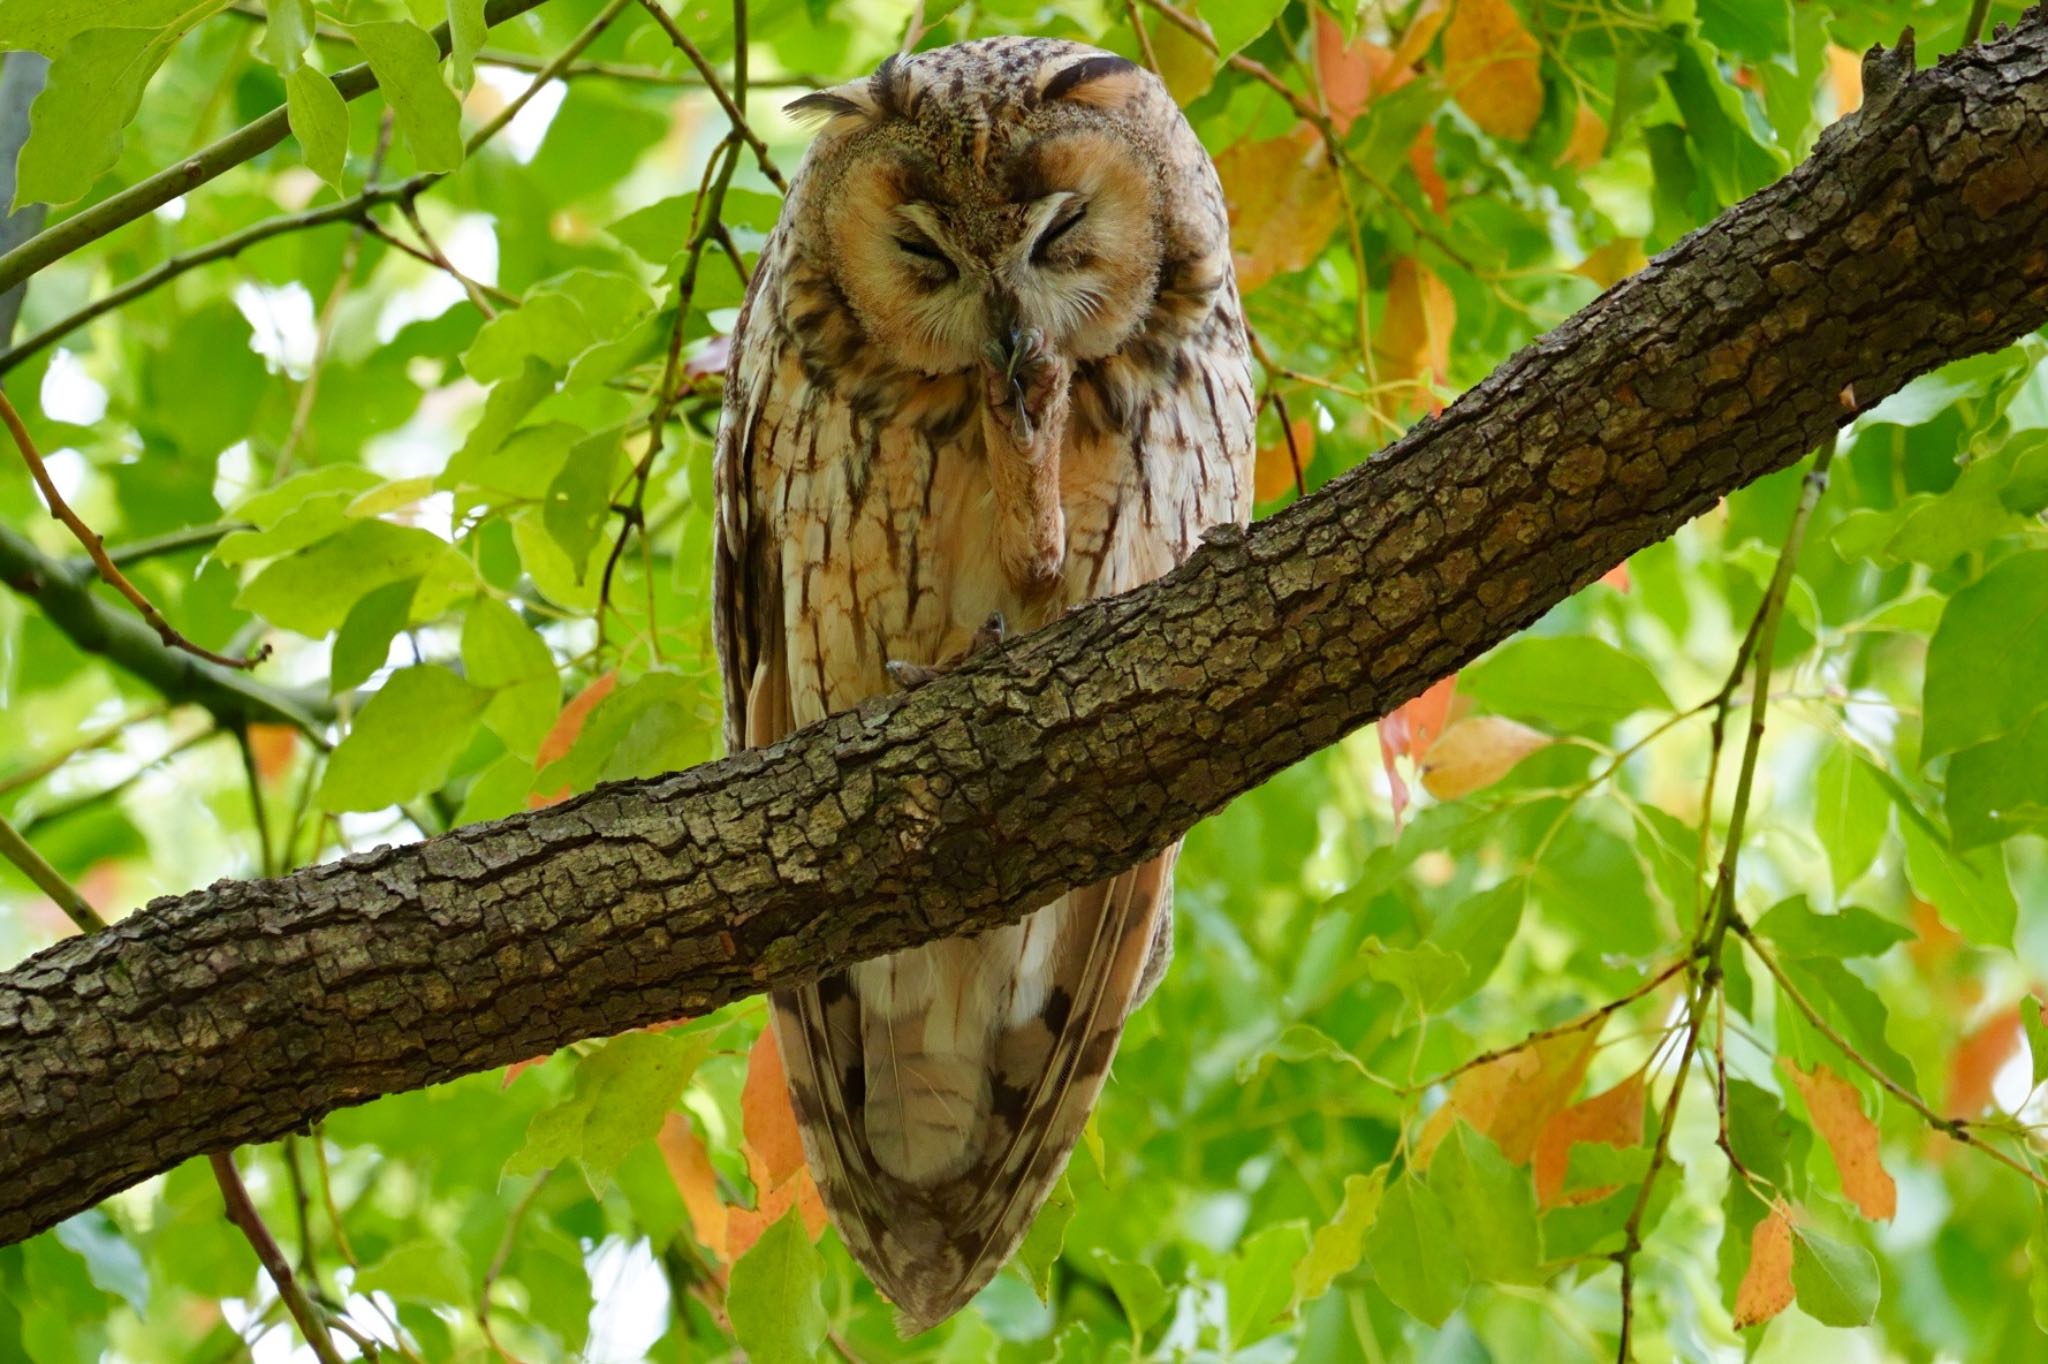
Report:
786,39,1204,375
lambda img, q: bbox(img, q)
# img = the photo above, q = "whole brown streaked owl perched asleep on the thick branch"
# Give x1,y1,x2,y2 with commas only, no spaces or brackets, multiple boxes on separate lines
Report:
713,37,1255,1333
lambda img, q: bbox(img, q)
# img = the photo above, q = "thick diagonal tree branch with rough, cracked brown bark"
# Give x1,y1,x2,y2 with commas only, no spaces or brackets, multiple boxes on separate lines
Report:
0,10,2048,1243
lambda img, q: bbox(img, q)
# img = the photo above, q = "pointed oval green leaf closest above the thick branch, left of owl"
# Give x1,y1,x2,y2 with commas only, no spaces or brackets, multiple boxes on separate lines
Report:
319,666,492,813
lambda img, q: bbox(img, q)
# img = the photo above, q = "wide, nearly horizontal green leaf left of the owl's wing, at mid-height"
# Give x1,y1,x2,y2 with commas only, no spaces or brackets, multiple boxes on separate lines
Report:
236,520,475,639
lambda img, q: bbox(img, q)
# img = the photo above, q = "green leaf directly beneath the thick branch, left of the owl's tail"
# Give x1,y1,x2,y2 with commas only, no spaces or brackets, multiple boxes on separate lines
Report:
506,1032,712,1187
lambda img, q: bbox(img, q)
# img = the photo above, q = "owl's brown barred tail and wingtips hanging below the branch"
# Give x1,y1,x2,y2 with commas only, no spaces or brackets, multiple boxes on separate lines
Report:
774,850,1174,1335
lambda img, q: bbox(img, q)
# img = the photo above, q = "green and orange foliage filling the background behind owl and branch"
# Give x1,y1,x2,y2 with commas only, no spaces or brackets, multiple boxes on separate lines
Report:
0,0,2048,1364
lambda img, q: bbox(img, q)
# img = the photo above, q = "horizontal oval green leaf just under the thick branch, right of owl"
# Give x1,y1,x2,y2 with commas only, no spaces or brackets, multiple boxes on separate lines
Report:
1458,635,1671,731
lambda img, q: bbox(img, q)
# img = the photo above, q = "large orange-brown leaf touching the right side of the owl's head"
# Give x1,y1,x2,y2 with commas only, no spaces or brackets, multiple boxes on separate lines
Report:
1217,123,1343,293
